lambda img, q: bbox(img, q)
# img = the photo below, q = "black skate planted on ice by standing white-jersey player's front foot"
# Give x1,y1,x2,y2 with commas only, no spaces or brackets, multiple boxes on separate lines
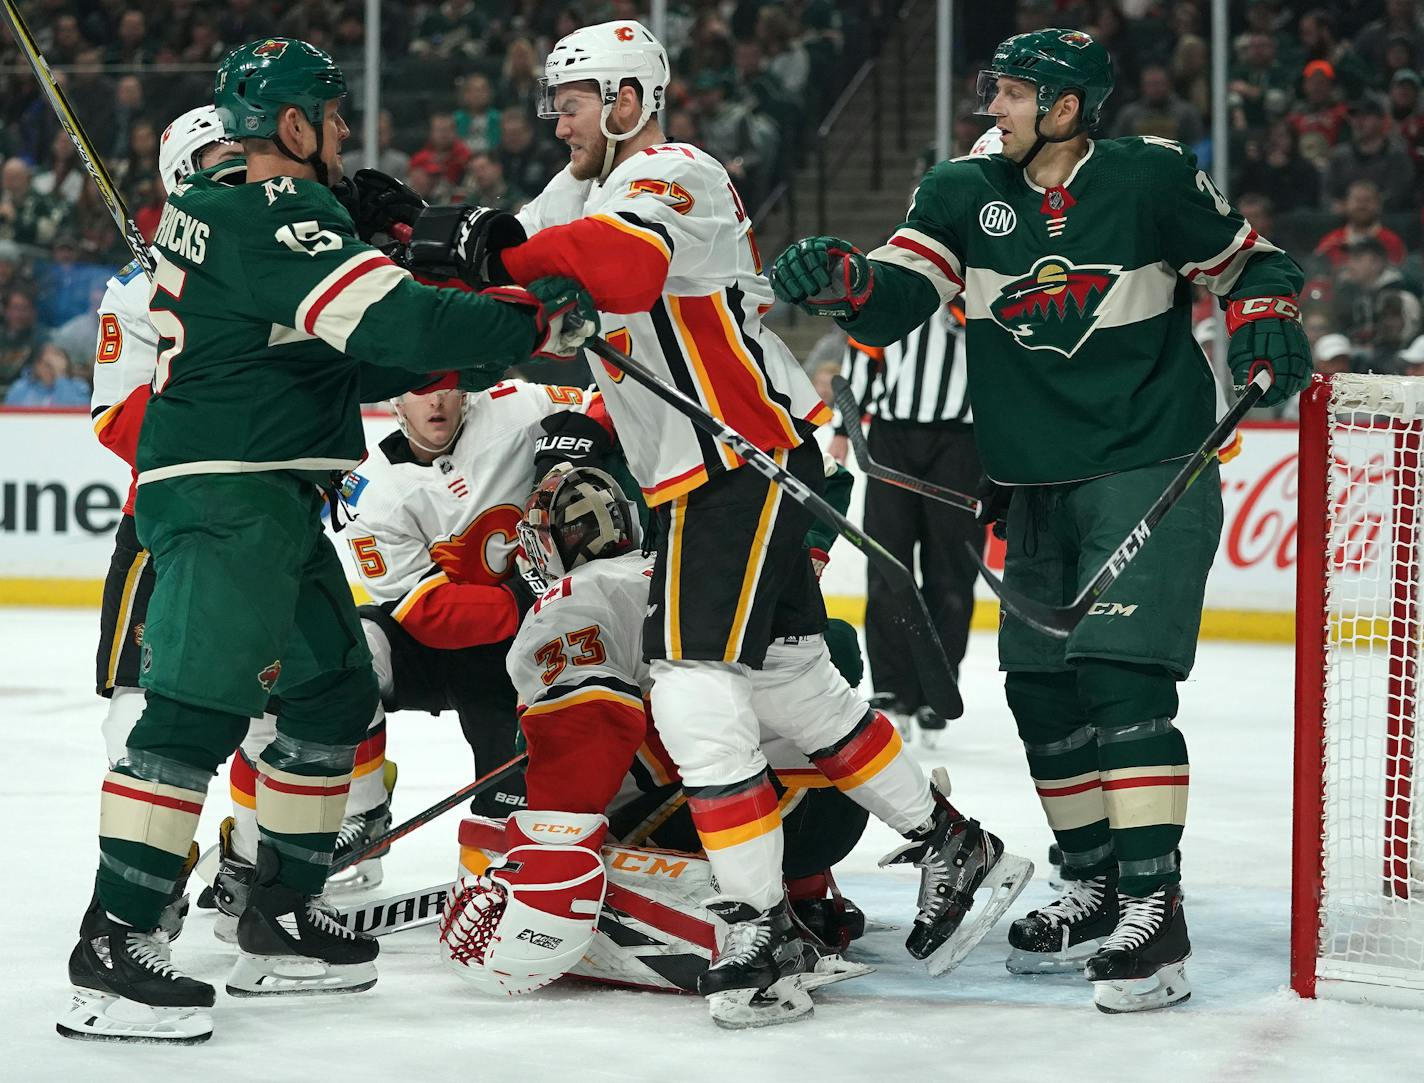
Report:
698,899,873,1030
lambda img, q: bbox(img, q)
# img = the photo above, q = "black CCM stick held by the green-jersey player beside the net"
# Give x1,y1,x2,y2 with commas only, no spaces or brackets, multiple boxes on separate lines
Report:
968,371,1270,639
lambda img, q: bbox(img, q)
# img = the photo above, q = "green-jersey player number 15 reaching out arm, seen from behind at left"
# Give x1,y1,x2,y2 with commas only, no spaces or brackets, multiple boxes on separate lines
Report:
58,38,597,1042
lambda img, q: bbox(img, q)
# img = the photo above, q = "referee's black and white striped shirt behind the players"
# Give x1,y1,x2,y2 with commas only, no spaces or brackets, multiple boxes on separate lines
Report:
840,305,974,426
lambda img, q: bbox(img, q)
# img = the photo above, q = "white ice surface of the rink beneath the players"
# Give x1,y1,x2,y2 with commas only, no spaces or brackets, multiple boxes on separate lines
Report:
0,609,1424,1083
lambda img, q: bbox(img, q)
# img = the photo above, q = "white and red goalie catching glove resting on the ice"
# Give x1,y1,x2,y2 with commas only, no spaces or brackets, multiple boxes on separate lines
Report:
440,810,608,996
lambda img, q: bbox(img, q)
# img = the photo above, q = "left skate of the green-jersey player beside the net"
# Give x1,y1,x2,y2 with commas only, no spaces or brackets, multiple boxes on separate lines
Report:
1004,865,1118,973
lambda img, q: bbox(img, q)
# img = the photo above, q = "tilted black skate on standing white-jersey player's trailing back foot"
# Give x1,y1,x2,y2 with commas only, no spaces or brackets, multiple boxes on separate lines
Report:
880,767,1034,976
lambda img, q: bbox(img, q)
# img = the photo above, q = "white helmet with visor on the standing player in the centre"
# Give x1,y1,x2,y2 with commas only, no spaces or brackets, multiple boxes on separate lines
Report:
538,20,672,176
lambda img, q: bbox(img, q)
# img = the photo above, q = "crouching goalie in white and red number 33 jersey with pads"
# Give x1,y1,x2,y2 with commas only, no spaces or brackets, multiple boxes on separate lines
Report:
441,465,866,993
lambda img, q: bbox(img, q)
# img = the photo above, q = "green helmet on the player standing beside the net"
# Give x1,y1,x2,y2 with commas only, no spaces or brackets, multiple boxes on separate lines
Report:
978,30,1114,131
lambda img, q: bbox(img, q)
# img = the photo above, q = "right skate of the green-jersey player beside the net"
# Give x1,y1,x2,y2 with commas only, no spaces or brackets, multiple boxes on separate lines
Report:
1084,884,1192,1015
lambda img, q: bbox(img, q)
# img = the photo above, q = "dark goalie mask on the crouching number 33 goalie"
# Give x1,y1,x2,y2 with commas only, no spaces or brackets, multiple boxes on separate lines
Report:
518,463,642,583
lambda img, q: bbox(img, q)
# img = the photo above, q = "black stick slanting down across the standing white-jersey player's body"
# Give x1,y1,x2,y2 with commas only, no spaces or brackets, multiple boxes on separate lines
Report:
585,337,964,719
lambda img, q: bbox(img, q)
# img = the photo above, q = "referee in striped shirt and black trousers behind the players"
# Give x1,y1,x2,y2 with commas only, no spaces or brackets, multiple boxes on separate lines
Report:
832,303,984,744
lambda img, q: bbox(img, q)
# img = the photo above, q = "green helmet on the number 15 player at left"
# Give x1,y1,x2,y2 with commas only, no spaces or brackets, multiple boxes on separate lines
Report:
212,37,346,139
